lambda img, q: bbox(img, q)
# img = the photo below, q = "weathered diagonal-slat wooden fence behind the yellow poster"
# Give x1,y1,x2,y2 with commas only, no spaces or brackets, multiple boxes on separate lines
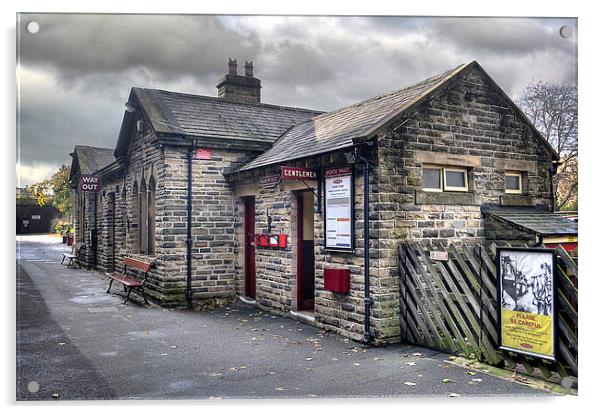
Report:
399,243,577,380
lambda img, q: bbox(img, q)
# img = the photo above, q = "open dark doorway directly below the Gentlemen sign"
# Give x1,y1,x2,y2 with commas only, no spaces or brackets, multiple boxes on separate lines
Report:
297,191,315,311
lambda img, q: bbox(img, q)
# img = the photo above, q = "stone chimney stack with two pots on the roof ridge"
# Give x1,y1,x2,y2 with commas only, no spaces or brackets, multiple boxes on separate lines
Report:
217,58,261,104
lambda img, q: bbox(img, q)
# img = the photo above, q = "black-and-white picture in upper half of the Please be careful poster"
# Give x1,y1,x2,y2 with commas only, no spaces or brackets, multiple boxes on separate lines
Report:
500,250,554,315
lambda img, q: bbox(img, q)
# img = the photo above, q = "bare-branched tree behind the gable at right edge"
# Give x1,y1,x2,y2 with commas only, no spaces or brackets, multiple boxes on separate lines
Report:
518,82,578,209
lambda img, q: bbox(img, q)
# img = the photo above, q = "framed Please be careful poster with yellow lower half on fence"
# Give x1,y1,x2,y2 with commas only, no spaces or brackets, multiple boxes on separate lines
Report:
497,247,558,361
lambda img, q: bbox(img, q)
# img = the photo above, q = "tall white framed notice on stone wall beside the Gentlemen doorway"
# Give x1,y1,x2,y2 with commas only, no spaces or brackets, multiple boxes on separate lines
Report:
324,166,354,251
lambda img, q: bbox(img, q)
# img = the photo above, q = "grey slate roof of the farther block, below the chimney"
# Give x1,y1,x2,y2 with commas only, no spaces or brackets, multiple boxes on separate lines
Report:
132,88,322,145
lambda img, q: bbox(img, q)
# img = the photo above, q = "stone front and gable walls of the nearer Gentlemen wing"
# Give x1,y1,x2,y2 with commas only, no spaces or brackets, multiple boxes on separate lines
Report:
232,63,552,344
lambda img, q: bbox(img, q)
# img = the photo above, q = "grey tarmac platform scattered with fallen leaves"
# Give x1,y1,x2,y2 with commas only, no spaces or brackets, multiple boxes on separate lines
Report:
17,236,551,400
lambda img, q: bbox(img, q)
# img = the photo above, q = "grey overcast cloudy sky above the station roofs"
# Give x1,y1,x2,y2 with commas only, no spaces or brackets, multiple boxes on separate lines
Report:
17,14,577,186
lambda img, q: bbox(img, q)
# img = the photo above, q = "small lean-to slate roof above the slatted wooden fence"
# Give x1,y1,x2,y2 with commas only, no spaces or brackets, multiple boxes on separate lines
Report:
490,209,578,236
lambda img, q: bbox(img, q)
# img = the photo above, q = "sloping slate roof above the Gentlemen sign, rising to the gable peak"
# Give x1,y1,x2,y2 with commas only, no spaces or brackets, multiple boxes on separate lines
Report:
232,64,469,171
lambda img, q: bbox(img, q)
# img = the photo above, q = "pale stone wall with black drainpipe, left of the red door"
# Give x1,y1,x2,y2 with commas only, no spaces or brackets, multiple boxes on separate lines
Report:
157,147,248,304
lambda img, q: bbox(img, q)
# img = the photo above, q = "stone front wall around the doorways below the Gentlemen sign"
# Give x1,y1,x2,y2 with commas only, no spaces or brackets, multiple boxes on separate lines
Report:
232,152,384,343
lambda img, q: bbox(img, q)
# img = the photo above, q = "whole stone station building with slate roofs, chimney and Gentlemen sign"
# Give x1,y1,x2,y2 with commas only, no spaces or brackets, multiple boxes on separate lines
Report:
72,60,558,344
